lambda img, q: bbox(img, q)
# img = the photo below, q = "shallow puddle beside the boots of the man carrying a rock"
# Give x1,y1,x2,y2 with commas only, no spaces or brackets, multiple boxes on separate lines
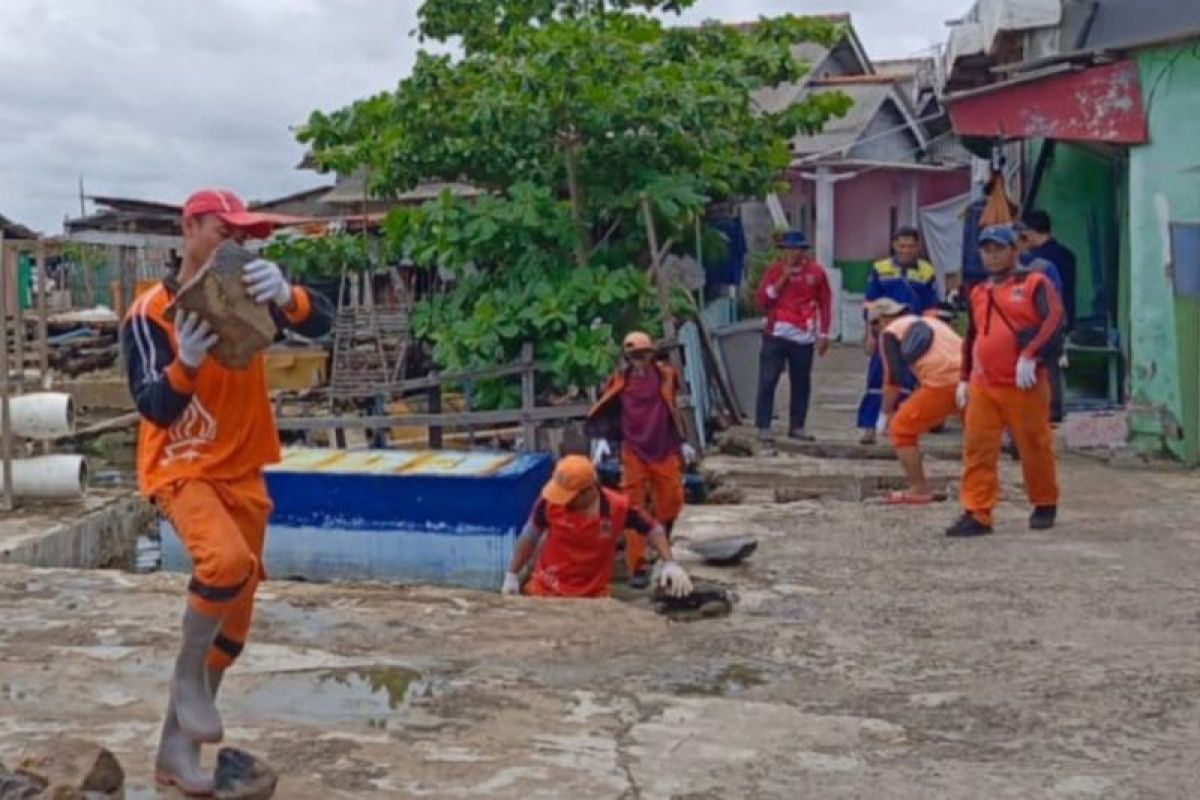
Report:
238,667,433,729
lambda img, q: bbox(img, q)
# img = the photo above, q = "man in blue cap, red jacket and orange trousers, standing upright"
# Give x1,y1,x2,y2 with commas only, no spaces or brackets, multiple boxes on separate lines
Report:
946,225,1063,537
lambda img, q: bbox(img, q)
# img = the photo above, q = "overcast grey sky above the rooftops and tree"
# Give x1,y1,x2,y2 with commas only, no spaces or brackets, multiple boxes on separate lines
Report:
0,0,970,233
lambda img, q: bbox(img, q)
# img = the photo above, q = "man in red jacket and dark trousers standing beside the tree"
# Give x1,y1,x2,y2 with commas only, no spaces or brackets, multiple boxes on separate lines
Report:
755,230,833,441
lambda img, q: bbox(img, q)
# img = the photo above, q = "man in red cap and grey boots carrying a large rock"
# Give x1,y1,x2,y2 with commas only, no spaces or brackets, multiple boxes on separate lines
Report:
121,190,332,795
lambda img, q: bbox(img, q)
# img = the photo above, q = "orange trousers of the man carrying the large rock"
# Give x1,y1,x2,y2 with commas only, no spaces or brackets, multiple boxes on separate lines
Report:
155,473,272,669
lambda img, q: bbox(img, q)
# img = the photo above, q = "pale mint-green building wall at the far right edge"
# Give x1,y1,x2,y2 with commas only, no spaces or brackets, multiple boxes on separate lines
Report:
1129,42,1200,464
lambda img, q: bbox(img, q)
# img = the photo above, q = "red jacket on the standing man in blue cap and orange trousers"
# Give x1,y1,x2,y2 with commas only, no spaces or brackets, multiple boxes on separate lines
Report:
962,270,1063,386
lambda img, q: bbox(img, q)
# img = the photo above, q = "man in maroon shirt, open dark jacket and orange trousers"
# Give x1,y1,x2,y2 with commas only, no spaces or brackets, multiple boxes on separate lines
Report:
587,331,696,589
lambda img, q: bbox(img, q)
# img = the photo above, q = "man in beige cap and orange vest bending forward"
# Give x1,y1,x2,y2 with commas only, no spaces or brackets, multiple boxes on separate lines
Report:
868,297,962,505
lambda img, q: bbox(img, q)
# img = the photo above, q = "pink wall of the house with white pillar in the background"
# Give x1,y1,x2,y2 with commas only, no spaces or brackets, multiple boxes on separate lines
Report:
781,169,971,261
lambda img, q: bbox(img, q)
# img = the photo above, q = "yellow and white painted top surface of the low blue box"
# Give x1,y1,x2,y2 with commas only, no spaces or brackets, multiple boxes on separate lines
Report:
268,447,521,477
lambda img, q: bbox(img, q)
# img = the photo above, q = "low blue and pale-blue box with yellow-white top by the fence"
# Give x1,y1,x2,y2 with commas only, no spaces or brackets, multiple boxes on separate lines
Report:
161,449,553,589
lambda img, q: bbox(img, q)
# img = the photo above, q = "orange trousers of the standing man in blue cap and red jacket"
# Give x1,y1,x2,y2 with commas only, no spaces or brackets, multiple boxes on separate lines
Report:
961,378,1058,525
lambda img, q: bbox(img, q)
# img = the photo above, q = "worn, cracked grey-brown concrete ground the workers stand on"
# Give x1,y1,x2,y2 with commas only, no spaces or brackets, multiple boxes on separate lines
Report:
0,351,1200,800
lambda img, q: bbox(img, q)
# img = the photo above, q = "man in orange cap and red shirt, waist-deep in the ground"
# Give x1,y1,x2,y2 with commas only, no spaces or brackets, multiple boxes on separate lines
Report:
502,456,691,597
